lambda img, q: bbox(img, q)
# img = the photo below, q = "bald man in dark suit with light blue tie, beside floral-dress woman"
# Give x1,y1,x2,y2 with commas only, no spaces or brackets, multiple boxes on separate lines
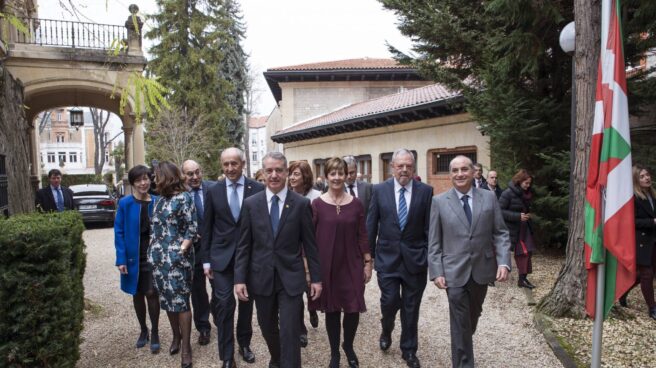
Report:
201,148,264,368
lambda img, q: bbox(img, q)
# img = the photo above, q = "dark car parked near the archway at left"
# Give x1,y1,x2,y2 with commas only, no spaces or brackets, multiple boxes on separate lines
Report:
69,184,116,226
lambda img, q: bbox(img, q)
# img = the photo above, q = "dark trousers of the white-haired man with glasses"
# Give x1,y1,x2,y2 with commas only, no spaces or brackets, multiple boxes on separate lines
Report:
377,266,427,355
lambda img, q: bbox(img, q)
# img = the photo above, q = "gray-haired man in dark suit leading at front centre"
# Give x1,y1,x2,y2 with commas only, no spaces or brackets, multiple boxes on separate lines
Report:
235,152,321,368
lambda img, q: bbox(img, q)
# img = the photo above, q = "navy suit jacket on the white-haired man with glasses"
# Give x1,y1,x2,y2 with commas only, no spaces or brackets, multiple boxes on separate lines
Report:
367,178,433,274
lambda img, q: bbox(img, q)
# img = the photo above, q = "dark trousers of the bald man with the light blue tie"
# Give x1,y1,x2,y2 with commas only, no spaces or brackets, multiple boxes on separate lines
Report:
211,266,253,360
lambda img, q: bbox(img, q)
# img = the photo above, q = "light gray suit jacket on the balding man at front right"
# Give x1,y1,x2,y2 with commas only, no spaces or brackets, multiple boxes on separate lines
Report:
428,186,511,287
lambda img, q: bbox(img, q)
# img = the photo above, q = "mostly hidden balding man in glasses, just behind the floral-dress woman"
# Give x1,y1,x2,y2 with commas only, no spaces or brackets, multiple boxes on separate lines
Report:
182,160,214,345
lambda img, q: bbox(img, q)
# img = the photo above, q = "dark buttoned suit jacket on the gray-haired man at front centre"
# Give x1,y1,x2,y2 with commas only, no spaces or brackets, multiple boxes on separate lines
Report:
235,190,321,296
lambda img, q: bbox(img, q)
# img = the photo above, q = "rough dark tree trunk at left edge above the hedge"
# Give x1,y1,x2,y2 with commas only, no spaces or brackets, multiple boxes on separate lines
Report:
0,63,34,214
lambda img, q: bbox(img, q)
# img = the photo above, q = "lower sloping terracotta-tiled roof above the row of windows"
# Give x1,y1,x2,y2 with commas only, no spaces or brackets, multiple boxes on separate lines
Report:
274,84,461,137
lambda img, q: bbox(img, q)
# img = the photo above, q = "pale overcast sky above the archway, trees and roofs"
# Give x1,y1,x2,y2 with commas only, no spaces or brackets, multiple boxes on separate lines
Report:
38,0,411,115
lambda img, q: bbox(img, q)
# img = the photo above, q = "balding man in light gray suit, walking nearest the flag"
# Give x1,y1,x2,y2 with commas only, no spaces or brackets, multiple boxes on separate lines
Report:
428,156,510,367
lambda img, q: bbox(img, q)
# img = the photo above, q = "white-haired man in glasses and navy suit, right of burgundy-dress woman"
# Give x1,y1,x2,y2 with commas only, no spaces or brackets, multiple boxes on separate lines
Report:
367,149,433,368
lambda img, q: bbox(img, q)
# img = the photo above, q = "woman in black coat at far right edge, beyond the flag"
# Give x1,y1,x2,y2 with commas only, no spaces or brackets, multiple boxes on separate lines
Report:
620,165,656,319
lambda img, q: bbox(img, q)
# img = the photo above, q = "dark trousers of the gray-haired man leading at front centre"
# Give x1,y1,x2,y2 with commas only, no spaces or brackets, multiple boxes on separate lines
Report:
251,273,303,368
